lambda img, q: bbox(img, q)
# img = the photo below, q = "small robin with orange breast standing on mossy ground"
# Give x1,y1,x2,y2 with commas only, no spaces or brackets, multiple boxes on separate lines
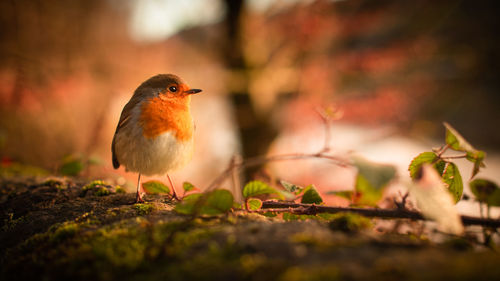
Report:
111,74,201,202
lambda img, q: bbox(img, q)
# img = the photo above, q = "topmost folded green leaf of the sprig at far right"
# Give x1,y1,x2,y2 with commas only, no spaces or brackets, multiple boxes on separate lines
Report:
444,122,486,178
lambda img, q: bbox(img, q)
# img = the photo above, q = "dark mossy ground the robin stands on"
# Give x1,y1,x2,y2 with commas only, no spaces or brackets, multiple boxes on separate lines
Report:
0,178,500,281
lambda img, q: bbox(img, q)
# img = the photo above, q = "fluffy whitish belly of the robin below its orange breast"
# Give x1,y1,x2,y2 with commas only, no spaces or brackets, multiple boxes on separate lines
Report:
115,128,193,176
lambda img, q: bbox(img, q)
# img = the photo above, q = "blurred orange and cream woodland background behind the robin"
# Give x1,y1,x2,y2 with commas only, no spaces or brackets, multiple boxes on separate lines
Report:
0,0,500,207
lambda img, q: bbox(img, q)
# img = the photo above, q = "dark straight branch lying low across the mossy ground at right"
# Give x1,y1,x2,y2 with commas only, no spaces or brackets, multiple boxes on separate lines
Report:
261,201,500,228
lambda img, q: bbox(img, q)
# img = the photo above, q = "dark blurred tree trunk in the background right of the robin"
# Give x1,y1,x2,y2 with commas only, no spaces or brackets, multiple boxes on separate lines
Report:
222,0,277,180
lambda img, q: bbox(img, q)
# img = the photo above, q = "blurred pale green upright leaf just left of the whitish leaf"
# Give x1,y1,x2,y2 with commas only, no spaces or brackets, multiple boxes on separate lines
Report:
353,157,396,189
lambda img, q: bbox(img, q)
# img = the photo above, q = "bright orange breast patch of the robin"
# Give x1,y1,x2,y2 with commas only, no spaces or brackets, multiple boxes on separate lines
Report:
139,97,193,141
